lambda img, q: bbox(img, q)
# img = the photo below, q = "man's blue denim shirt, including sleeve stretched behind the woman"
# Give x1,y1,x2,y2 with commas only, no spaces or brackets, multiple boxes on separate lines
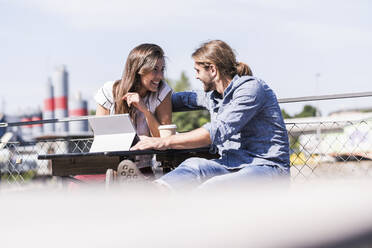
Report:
172,75,289,171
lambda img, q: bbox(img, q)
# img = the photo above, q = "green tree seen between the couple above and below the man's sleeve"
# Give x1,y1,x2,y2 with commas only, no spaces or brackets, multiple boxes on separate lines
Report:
167,72,210,132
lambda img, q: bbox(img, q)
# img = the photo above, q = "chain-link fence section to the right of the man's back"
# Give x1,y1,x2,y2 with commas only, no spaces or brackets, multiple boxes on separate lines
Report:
286,116,372,181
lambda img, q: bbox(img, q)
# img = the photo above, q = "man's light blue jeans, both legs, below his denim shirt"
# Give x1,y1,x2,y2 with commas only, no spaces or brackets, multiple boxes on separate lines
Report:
157,158,289,190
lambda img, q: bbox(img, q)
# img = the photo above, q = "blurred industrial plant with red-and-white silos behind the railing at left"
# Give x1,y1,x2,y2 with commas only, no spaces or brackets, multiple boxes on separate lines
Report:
0,65,91,142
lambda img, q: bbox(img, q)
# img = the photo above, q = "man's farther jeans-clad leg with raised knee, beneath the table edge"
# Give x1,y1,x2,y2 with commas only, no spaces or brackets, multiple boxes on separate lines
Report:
155,158,229,190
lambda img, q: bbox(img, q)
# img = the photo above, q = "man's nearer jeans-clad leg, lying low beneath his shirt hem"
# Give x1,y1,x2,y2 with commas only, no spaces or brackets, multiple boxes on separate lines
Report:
199,165,289,189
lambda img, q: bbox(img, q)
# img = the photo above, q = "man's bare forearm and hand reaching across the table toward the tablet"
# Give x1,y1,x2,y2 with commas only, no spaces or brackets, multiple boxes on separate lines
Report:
131,127,211,150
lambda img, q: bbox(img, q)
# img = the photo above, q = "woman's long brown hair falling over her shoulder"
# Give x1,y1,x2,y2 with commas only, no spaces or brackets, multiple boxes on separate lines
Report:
113,44,164,119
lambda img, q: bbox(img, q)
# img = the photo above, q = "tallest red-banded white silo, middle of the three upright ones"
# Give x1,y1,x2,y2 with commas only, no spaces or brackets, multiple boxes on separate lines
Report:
53,66,68,133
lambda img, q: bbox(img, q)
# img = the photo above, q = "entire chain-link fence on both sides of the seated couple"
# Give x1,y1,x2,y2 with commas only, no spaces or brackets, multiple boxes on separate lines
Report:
0,117,372,184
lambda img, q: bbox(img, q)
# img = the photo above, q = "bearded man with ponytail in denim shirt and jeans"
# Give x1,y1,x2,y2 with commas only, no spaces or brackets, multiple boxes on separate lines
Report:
132,40,289,189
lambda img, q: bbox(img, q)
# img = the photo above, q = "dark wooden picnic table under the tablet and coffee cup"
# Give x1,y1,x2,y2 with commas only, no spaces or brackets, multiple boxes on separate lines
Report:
38,147,219,177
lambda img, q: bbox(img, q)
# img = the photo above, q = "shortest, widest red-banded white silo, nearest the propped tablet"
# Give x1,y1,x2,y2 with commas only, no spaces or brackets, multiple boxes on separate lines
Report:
69,92,88,133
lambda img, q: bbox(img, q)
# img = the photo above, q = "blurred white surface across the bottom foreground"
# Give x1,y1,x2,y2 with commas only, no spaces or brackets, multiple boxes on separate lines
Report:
0,178,372,247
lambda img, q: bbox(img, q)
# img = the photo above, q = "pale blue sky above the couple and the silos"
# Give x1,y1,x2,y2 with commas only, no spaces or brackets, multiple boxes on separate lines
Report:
0,0,372,114
